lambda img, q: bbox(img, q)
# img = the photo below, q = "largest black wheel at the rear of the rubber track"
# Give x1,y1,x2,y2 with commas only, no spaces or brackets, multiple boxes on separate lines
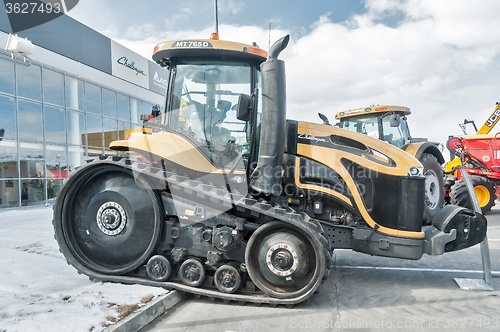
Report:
54,161,161,275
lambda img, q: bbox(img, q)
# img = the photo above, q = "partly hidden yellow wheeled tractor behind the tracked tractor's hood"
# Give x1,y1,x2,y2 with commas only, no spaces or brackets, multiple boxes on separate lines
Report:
335,105,445,224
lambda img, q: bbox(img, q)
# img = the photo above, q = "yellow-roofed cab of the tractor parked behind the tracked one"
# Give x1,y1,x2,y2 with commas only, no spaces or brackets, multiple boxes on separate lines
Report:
335,105,411,148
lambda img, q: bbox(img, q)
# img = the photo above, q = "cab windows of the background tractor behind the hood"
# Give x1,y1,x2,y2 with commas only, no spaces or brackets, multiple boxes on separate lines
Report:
339,113,410,148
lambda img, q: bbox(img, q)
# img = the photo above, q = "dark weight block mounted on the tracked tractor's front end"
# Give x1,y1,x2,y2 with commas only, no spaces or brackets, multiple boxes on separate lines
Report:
424,205,487,255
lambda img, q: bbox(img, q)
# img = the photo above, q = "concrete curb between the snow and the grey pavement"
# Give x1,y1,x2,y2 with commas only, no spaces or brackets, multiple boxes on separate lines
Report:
103,290,184,332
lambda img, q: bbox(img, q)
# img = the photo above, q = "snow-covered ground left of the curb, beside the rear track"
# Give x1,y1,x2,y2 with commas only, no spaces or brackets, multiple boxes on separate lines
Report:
0,207,167,332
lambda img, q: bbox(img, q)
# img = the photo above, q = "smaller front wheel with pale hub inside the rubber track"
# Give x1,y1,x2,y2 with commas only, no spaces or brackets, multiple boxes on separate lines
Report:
245,222,325,299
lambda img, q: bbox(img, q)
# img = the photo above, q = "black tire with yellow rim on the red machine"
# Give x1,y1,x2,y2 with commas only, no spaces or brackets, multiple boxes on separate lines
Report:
450,175,496,214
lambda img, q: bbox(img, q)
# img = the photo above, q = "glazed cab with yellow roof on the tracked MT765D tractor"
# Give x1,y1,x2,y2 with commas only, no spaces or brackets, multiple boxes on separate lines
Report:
148,39,267,168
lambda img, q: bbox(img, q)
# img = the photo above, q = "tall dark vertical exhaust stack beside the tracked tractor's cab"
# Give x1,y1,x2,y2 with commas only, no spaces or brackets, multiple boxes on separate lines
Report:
250,35,290,195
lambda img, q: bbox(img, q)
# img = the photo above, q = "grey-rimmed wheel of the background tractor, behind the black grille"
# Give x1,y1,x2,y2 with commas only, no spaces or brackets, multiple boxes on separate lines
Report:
420,153,444,225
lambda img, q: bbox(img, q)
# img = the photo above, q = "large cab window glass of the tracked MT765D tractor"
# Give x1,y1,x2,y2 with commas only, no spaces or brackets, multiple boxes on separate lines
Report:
170,60,251,167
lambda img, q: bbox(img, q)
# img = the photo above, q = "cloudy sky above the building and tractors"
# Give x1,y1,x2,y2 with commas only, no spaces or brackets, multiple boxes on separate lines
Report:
70,0,500,154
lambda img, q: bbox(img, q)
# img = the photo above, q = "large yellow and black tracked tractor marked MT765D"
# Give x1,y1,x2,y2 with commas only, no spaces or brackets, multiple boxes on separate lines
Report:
54,36,487,306
